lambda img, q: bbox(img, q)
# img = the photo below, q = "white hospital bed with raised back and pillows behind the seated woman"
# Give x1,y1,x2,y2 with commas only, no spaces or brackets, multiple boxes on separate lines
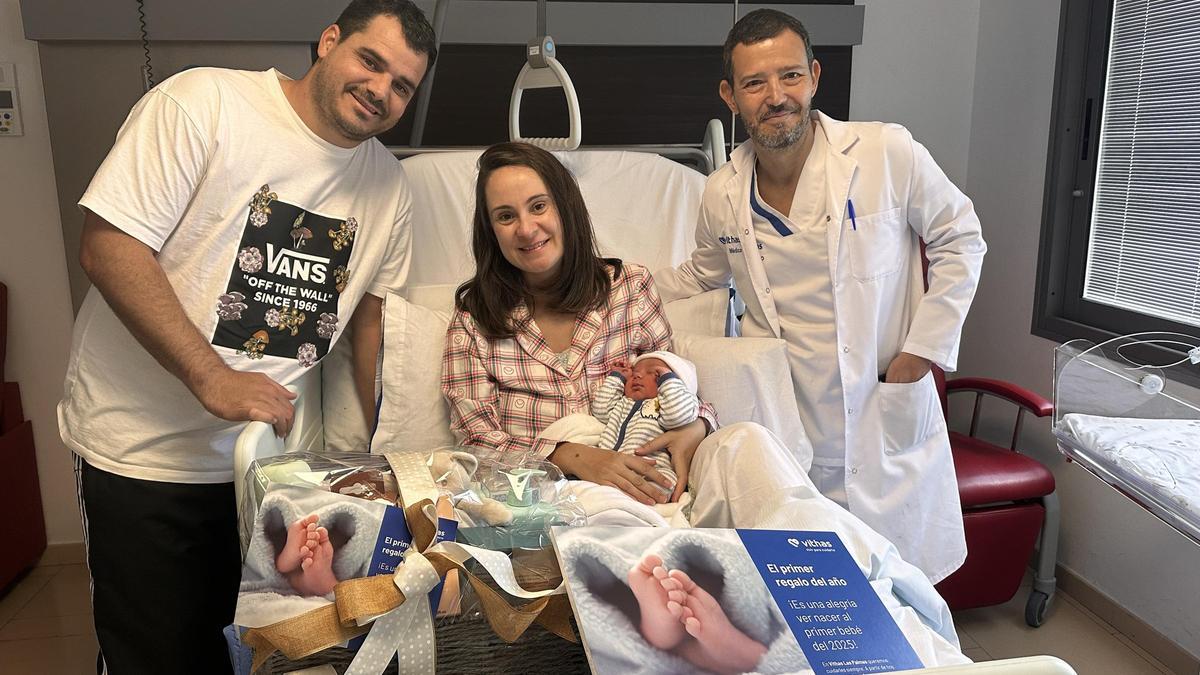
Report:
235,144,1072,675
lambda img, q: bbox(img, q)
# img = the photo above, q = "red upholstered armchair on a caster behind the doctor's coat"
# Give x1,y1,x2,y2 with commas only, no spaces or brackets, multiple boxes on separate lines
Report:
934,368,1058,627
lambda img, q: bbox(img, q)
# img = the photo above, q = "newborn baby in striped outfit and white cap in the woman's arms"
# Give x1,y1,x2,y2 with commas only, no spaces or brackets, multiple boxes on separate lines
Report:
592,352,700,494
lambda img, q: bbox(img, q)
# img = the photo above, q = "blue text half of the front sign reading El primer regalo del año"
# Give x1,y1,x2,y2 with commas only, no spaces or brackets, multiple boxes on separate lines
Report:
737,530,923,675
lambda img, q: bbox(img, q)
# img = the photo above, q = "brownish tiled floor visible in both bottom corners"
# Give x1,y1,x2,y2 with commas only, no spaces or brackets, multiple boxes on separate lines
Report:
0,561,1170,675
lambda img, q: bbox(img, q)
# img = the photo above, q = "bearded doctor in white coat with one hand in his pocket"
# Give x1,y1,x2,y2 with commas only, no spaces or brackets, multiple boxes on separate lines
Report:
654,10,985,583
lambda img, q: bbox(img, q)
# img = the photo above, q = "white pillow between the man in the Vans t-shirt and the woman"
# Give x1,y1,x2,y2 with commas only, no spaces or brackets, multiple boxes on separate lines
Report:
371,294,455,453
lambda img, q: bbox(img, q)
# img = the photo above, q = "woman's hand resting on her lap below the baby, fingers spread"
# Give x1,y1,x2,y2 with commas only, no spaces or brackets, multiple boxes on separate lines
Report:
546,443,671,506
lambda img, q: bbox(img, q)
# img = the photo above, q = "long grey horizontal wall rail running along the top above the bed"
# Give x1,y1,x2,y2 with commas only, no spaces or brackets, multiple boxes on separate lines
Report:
20,0,863,46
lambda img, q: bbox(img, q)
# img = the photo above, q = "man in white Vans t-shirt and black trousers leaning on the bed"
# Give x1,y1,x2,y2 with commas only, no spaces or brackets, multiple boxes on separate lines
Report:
59,0,437,674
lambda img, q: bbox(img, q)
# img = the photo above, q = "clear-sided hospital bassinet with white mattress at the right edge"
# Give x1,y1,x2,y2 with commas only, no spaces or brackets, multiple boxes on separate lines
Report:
1054,333,1200,544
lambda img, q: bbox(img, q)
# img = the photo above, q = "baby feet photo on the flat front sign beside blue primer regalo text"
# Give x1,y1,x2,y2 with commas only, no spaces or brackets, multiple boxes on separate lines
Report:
553,527,777,675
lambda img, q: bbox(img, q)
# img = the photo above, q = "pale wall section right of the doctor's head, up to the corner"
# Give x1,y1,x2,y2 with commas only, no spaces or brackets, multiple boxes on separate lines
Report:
850,0,979,187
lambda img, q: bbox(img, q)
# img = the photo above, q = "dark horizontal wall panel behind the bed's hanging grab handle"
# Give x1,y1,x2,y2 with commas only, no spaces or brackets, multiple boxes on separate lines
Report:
383,44,851,145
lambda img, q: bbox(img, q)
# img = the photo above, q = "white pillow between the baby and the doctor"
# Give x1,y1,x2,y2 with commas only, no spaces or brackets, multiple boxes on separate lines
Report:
674,333,812,472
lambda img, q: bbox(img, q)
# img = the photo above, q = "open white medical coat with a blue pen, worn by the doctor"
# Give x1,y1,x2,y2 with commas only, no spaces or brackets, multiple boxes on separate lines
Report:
654,113,986,583
